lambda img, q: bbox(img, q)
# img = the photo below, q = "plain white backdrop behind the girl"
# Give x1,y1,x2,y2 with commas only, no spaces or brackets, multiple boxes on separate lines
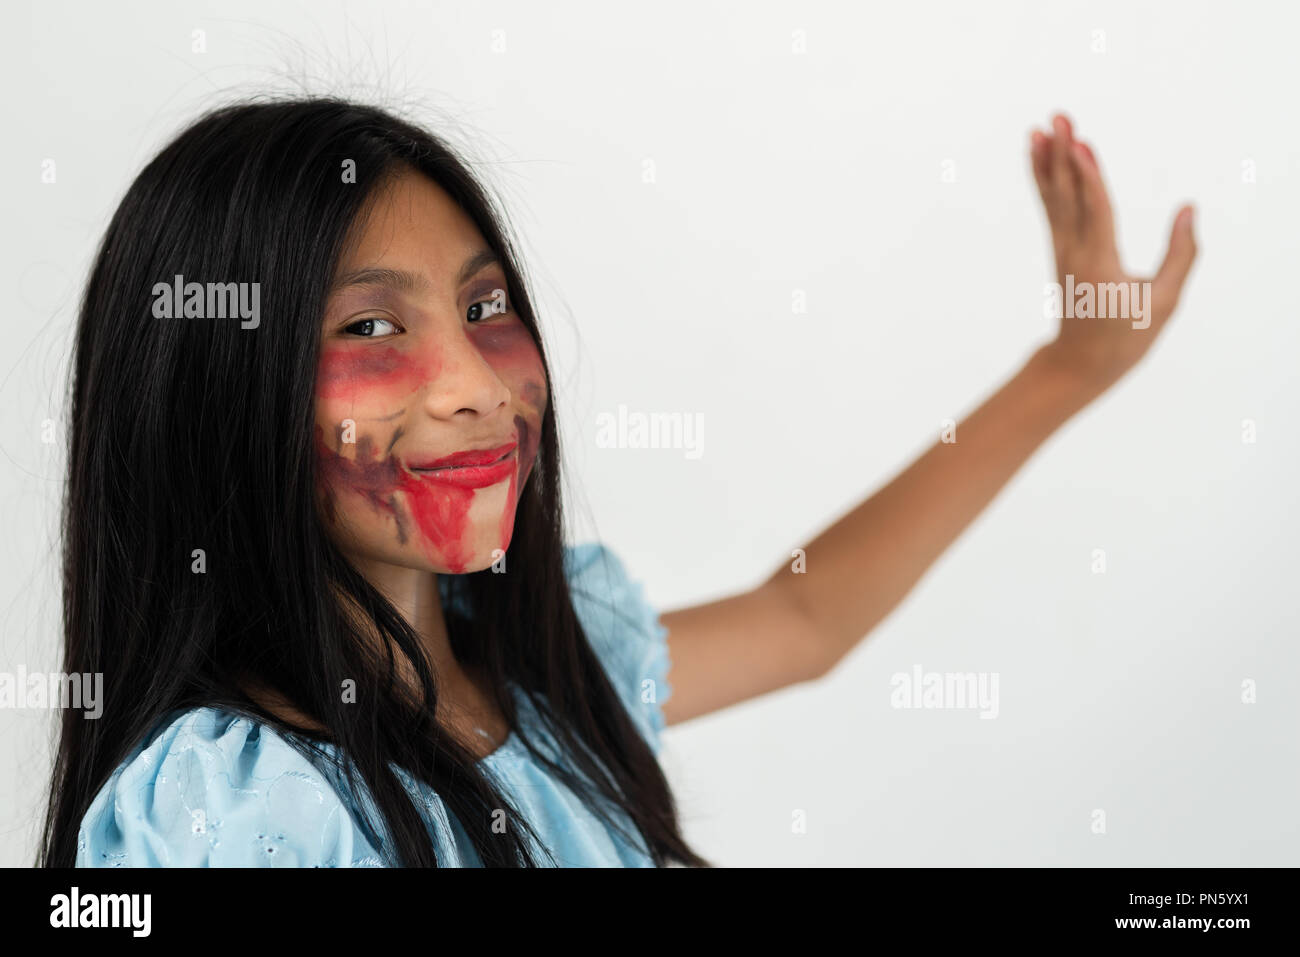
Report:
0,0,1300,866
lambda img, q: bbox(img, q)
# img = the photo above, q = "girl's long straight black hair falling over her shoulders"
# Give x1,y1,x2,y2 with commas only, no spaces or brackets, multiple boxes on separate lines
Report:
39,98,707,866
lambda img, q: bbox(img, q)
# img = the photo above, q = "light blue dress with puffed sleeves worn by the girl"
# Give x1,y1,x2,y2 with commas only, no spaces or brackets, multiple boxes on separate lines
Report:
77,544,672,867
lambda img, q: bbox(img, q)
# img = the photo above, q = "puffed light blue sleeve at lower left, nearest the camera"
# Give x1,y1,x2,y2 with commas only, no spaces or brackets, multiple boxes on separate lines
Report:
77,707,382,867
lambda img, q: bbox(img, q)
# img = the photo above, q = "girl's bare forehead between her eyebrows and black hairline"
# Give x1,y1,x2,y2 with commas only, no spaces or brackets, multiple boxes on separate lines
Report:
339,168,486,277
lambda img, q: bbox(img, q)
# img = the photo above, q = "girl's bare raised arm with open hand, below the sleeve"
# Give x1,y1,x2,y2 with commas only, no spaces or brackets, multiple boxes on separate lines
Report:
662,116,1196,724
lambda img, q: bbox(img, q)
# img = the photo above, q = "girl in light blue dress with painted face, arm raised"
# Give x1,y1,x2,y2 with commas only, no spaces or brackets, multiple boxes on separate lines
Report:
42,99,1195,867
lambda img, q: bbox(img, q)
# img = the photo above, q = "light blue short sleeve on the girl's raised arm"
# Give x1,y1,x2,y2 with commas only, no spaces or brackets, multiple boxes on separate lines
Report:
564,542,672,754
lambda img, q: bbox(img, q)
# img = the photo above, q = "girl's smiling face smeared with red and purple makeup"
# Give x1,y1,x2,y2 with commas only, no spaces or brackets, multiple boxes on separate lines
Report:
316,170,547,573
